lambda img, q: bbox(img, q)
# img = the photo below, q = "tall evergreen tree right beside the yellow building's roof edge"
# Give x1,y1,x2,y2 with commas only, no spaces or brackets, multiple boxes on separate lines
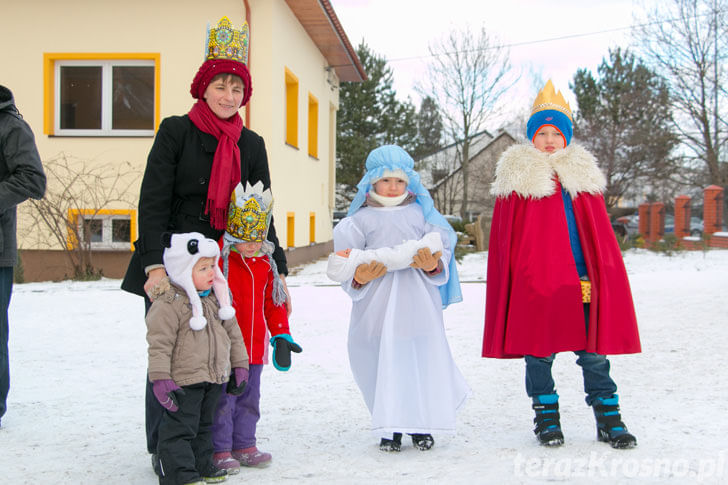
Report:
336,42,417,202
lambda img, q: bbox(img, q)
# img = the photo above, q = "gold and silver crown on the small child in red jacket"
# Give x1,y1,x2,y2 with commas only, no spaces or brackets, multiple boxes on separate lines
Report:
225,181,273,242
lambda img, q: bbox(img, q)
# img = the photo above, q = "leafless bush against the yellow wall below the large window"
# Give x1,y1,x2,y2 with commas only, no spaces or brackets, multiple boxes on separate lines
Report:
22,153,140,279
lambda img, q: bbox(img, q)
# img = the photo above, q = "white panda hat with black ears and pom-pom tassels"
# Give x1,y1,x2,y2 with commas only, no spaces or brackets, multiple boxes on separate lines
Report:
162,232,235,330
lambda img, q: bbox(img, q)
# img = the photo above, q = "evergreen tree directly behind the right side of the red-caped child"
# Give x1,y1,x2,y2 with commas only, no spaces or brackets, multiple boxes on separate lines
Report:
571,48,678,207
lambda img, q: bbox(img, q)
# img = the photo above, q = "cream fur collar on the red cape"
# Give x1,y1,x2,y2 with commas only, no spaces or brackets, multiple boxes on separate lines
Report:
490,144,607,199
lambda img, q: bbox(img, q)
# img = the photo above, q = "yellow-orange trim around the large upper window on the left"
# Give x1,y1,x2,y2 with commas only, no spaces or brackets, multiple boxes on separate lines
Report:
43,52,161,135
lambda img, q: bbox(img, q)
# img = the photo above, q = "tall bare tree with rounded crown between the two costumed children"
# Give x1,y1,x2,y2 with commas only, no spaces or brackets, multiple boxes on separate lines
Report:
416,24,518,220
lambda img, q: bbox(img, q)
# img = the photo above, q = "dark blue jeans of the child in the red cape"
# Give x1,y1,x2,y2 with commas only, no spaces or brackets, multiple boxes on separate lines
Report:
526,304,617,406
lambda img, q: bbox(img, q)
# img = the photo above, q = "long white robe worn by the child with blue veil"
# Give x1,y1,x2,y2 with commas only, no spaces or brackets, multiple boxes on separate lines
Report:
334,203,470,436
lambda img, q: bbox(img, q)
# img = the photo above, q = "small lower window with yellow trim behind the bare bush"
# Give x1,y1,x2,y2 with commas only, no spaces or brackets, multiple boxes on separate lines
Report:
68,209,136,249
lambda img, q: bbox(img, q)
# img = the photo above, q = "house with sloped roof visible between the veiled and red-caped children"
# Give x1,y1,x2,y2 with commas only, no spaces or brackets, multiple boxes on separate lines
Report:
418,130,516,220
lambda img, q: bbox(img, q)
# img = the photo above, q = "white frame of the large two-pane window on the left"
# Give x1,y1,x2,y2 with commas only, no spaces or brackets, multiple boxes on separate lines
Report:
53,59,157,136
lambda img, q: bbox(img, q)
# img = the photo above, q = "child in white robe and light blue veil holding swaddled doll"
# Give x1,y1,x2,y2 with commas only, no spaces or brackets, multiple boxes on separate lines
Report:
334,145,469,451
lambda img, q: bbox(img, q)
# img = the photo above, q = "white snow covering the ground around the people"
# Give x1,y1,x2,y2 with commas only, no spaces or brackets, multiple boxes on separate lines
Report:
0,250,728,484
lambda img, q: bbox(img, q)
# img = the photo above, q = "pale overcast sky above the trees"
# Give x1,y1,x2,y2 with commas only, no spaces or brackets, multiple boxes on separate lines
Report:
331,0,651,128
